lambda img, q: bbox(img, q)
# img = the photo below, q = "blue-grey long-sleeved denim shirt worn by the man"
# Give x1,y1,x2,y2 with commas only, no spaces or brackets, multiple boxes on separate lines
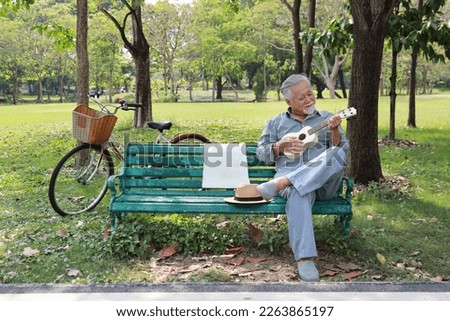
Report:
256,108,348,174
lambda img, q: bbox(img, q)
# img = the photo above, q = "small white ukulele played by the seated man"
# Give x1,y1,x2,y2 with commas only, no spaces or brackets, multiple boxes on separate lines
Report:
283,107,356,160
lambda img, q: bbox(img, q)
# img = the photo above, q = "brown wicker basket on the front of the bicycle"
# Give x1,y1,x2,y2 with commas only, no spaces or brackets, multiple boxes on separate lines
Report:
72,105,117,145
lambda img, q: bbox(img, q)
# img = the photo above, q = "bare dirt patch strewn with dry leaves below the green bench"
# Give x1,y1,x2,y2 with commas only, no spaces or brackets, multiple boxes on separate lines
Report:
149,240,366,283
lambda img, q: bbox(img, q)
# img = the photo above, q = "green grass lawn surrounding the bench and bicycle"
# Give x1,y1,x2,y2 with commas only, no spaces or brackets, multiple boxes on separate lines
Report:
0,93,450,283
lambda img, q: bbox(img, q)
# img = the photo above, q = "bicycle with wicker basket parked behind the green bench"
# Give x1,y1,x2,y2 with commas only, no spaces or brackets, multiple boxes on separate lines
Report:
48,93,210,216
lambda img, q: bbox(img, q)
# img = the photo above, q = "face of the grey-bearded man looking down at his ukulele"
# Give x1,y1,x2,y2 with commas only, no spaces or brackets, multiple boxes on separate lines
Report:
286,81,316,118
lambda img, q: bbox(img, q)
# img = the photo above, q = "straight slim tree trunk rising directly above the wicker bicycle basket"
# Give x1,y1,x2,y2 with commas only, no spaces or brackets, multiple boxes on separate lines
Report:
76,0,89,105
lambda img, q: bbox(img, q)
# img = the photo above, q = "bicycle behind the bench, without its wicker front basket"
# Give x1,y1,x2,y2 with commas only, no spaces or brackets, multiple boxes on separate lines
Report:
48,93,209,216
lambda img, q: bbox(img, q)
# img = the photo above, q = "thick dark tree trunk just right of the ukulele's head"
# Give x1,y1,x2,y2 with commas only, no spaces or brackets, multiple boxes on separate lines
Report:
347,0,399,184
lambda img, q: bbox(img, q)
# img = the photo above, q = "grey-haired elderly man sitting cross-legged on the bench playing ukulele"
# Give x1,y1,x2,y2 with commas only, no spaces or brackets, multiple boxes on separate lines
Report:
257,74,348,281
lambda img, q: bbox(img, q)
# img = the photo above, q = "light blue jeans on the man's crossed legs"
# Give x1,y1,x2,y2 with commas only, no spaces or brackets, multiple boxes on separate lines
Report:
276,147,345,260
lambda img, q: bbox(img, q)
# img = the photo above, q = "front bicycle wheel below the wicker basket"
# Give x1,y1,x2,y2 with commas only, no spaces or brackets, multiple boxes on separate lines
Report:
48,144,114,216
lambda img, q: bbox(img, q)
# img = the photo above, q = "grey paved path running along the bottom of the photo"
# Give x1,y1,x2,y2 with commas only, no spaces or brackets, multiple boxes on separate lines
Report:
0,282,450,301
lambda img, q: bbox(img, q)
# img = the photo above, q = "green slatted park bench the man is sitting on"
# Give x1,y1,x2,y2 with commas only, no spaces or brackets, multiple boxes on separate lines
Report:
108,143,353,235
